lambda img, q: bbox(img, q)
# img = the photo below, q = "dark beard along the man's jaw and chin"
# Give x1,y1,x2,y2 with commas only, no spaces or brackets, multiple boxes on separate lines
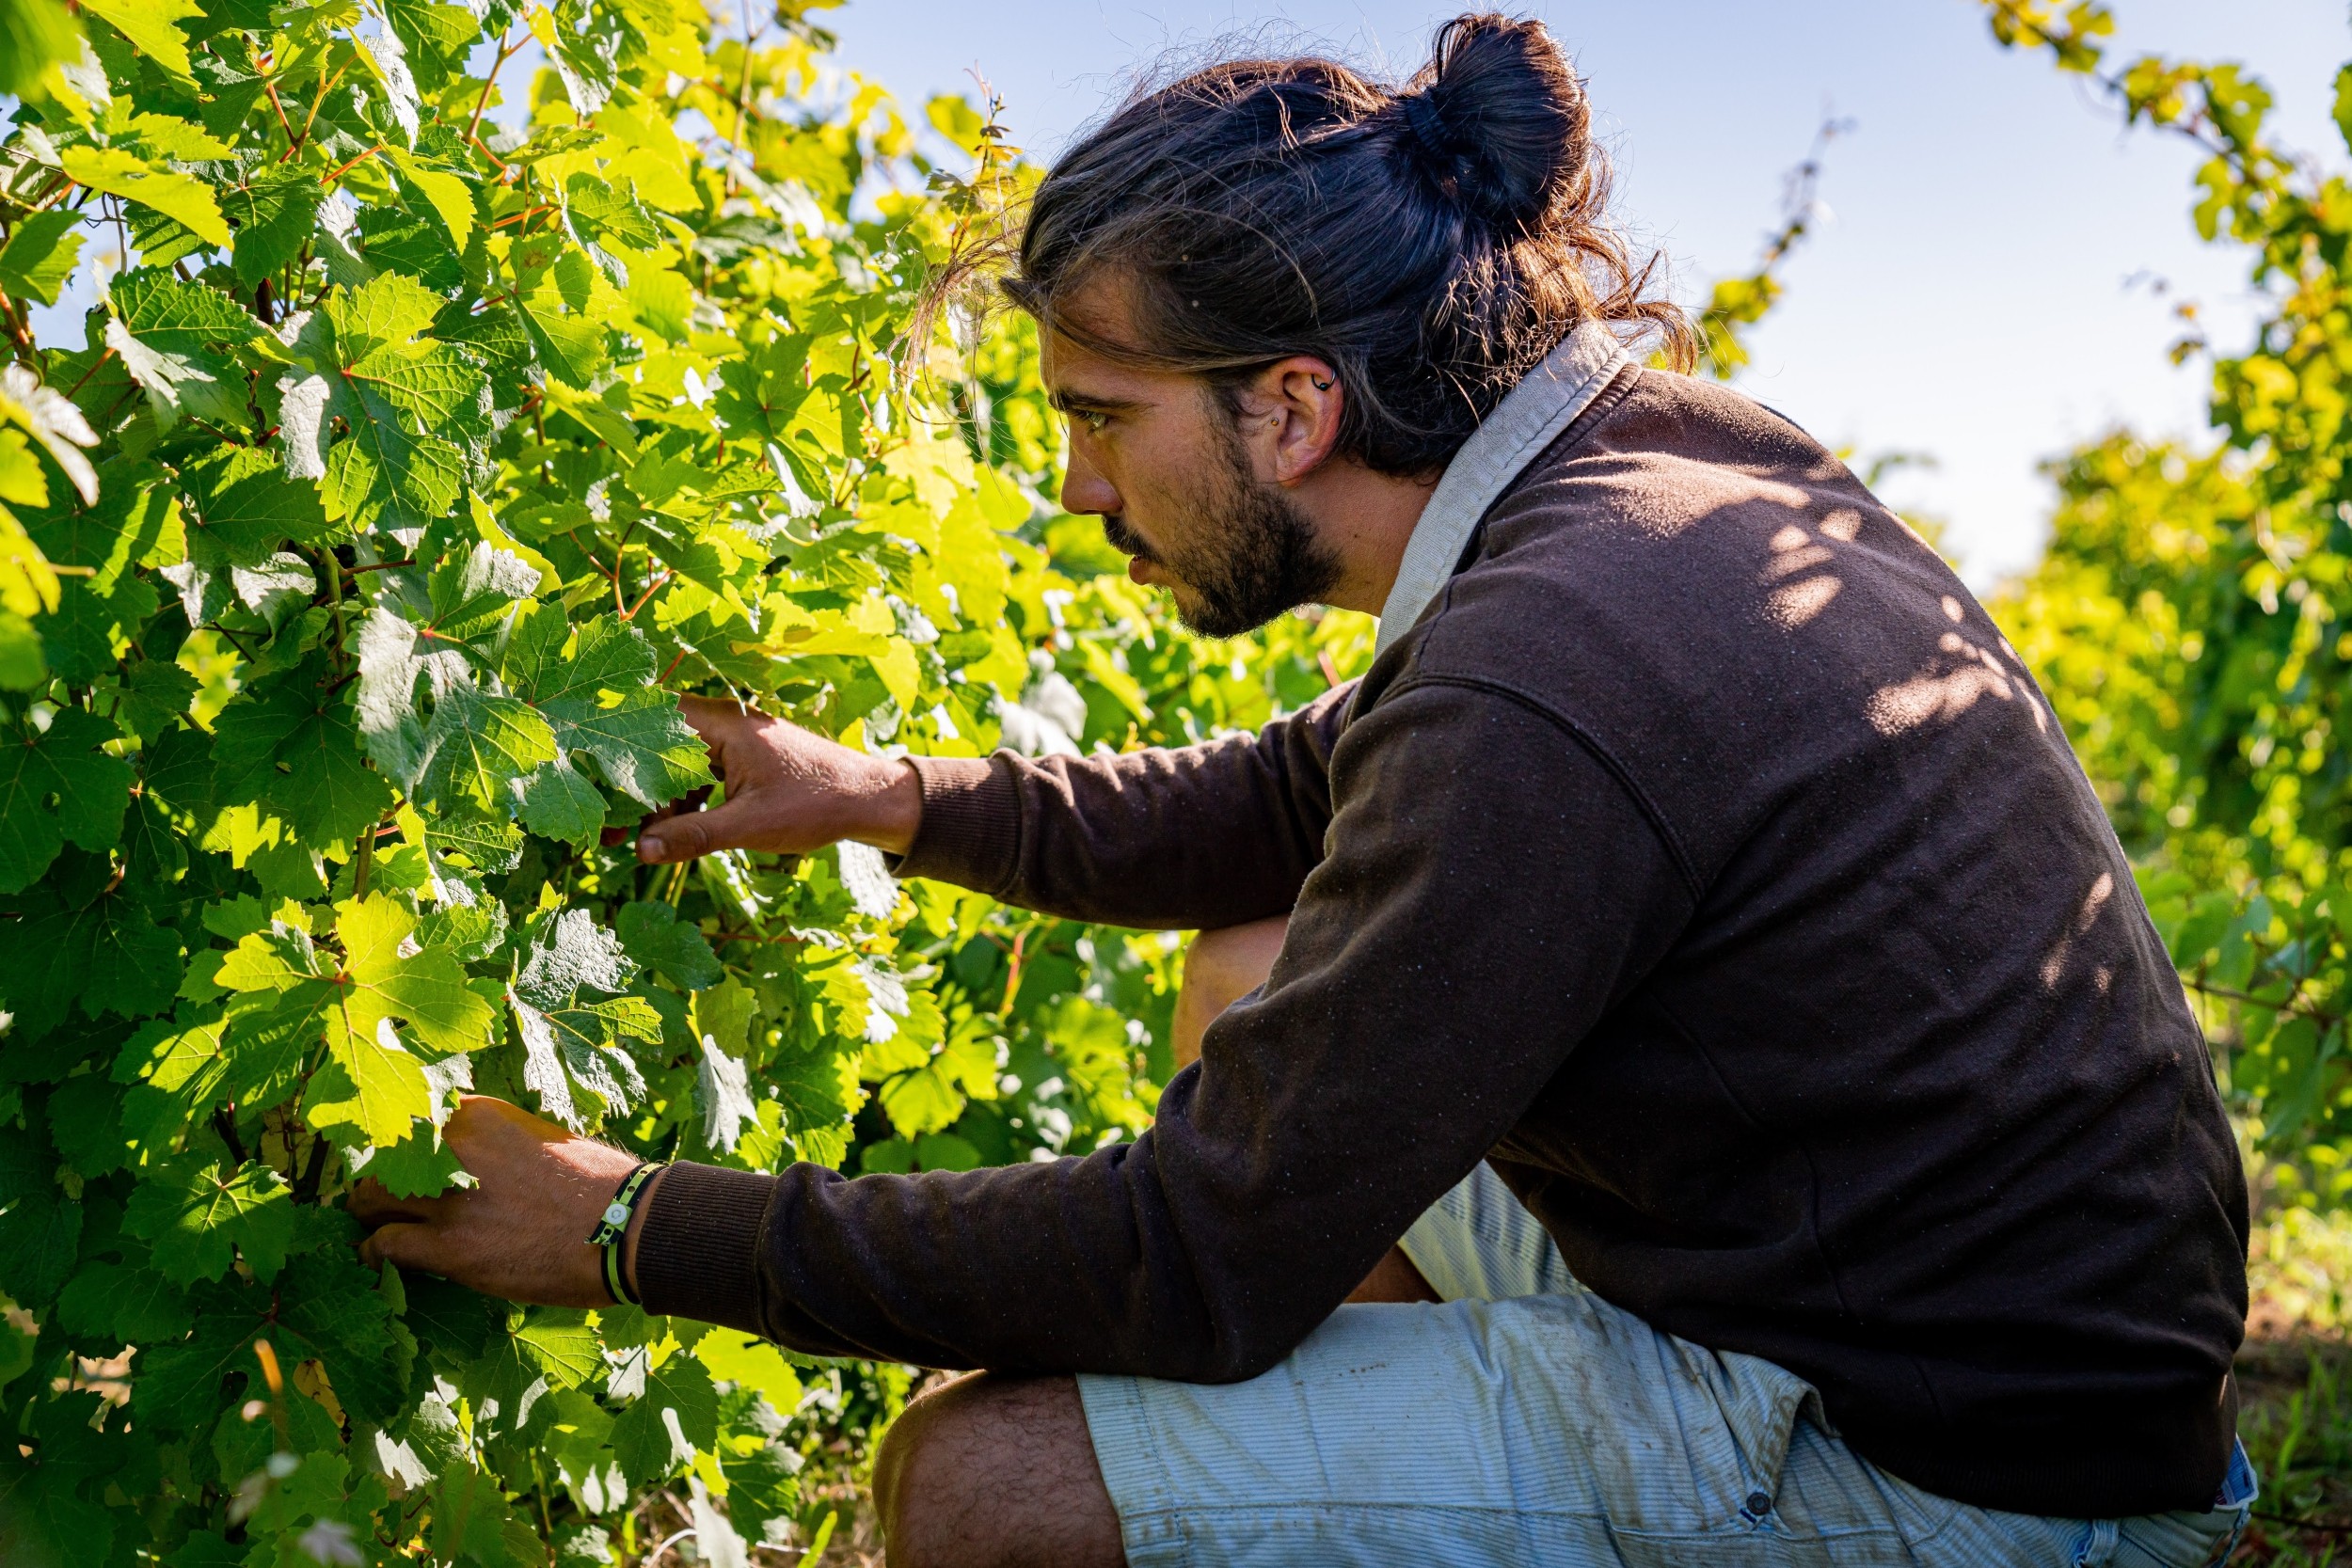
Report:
1104,416,1341,637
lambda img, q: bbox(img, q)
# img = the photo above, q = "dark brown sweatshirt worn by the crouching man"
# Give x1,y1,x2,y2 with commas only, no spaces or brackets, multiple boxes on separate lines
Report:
638,369,2247,1516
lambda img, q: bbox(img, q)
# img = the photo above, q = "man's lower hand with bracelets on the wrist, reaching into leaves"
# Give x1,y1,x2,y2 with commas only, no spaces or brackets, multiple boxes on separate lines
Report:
351,1096,661,1307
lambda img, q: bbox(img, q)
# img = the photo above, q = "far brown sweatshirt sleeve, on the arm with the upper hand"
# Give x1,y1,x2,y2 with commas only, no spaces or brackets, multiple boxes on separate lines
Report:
894,682,1355,928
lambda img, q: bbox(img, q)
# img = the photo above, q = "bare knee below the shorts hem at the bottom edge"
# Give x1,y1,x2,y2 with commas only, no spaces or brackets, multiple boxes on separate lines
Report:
875,1373,1127,1568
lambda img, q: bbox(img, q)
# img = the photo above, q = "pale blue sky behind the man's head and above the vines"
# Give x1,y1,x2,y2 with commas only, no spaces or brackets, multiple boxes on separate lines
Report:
821,0,2352,585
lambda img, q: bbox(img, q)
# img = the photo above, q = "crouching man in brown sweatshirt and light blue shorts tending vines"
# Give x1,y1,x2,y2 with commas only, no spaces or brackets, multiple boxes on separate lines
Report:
362,16,2251,1568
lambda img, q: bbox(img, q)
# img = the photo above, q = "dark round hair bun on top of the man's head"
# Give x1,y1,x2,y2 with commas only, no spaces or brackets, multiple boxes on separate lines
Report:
1397,11,1590,230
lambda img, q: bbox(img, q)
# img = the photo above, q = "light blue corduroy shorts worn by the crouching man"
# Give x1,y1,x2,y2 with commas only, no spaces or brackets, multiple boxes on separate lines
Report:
1077,1166,2253,1568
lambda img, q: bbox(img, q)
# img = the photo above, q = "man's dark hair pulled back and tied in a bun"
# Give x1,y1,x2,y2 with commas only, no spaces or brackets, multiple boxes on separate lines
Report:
1005,14,1692,475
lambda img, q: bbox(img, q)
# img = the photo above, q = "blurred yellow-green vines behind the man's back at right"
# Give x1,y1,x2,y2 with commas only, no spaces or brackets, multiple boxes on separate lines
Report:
1988,0,2352,1204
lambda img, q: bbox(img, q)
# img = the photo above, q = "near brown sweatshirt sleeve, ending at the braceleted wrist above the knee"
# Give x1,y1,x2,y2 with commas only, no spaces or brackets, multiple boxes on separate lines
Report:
638,682,1692,1383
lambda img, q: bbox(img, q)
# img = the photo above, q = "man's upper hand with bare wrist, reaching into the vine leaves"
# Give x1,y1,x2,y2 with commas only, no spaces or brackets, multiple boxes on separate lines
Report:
638,696,922,865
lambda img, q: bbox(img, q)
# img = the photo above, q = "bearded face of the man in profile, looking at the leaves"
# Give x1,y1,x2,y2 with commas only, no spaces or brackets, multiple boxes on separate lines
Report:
1044,291,1339,637
